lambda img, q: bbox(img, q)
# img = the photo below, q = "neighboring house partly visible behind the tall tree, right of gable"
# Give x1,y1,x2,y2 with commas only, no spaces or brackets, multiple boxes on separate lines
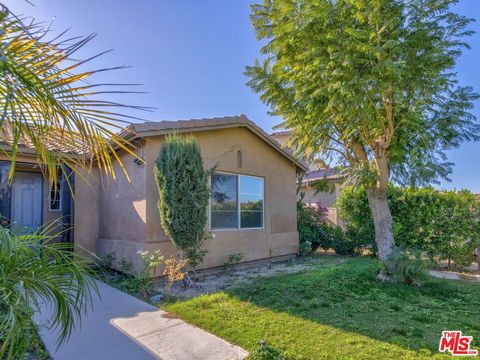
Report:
271,131,344,225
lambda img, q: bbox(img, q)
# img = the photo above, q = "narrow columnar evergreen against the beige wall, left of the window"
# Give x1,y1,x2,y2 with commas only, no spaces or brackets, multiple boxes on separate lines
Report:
154,134,209,265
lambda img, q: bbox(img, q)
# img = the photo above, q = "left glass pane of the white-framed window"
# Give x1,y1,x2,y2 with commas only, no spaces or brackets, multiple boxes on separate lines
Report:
211,174,238,229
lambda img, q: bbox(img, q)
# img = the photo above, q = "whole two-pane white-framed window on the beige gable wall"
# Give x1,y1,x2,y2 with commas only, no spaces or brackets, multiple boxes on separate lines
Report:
210,173,265,230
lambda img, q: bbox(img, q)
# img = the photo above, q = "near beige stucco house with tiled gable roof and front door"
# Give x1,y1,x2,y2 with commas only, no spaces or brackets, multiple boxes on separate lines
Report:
0,115,307,269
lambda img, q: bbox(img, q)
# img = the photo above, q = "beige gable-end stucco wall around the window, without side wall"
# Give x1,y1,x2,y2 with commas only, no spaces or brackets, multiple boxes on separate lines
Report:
140,128,298,268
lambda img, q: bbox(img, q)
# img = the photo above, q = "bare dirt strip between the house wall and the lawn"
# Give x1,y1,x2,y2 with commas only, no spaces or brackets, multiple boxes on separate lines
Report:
156,256,346,300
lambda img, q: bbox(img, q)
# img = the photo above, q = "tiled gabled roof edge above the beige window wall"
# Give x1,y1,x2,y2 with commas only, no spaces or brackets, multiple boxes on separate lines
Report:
120,115,308,171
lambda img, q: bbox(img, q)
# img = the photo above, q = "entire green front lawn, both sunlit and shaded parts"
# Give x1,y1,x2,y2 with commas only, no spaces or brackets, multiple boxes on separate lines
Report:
165,257,480,359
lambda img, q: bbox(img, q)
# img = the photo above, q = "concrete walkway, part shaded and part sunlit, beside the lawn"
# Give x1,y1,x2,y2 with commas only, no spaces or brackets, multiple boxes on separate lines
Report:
35,282,248,360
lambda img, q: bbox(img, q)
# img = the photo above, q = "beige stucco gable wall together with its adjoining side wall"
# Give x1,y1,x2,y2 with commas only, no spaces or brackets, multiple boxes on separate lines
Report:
92,128,298,268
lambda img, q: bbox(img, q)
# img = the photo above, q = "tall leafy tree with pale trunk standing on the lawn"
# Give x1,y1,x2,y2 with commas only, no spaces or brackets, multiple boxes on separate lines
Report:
246,0,480,277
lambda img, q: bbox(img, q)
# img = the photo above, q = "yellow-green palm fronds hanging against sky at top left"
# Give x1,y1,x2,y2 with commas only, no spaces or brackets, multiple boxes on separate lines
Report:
0,2,151,186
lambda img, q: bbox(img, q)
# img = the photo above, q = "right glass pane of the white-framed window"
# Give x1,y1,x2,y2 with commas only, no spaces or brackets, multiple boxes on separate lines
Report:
240,176,263,228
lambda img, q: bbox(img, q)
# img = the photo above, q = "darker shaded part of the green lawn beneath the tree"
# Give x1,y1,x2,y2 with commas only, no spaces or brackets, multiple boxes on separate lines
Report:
226,258,480,352
